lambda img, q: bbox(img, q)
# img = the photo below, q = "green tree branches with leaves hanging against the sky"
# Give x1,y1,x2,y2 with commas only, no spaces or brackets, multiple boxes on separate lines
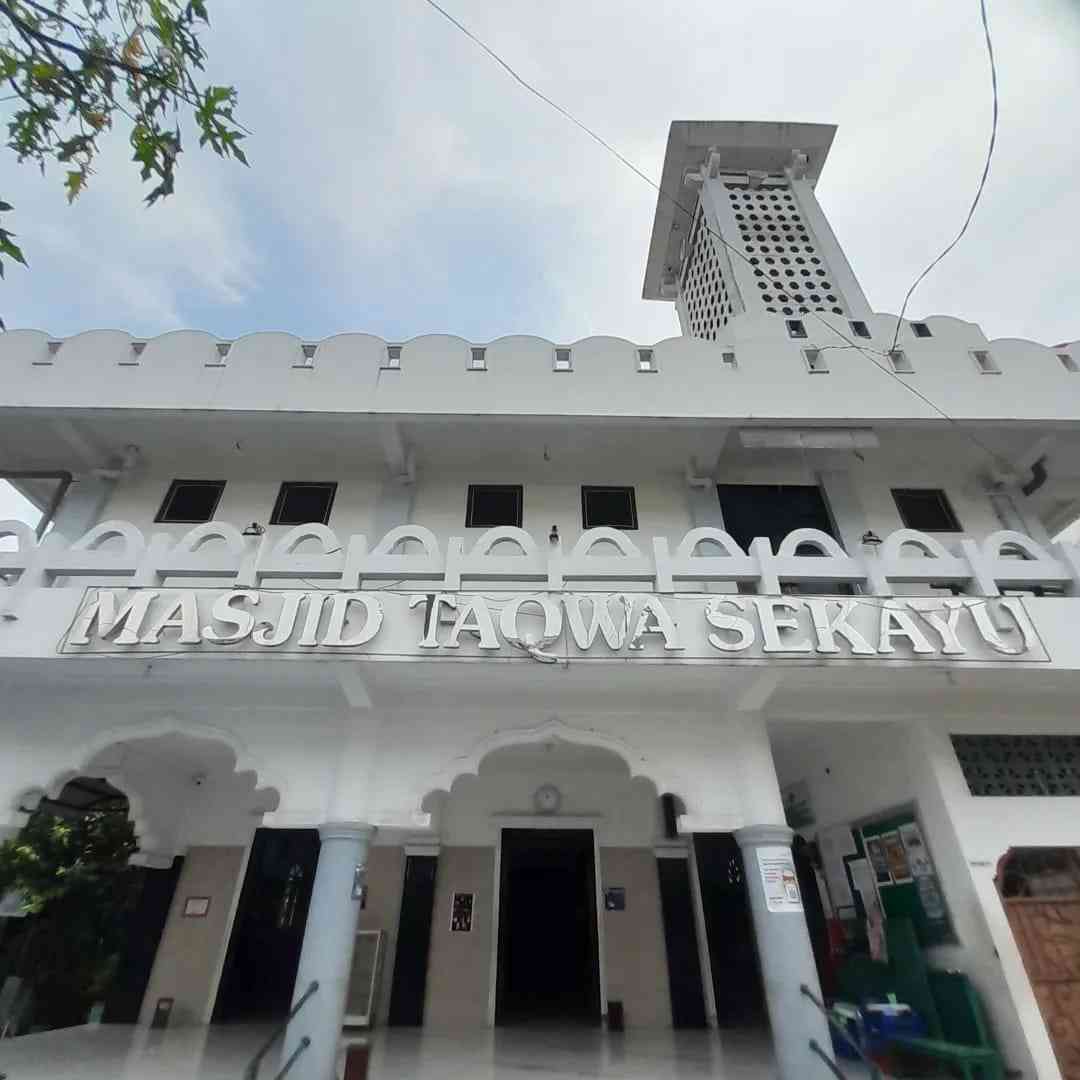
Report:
0,0,247,276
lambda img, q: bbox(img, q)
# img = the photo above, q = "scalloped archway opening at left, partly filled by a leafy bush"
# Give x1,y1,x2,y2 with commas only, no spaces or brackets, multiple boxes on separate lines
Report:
1,721,279,1026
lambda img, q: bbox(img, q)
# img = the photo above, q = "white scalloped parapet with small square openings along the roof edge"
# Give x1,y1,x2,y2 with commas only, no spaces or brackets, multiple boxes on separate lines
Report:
0,313,1080,421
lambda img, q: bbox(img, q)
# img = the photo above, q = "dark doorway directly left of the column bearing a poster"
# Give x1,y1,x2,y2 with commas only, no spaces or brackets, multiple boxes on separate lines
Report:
693,833,767,1027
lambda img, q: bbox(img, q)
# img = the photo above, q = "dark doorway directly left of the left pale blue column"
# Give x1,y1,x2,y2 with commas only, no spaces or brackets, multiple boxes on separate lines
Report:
214,828,319,1021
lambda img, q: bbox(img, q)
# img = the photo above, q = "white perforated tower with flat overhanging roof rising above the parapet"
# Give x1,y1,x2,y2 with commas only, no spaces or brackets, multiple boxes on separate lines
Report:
643,121,870,341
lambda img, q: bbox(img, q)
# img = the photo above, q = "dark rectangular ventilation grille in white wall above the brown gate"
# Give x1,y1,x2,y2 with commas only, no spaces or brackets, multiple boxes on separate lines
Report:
953,735,1080,796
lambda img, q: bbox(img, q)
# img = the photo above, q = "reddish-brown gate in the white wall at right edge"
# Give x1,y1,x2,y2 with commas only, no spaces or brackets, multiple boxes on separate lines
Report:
997,848,1080,1080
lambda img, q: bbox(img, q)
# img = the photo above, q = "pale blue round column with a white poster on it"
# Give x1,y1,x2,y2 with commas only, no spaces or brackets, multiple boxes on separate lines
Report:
735,825,833,1080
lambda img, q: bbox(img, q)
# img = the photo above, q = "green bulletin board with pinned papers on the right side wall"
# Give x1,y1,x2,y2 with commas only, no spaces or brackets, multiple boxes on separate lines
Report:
845,809,956,948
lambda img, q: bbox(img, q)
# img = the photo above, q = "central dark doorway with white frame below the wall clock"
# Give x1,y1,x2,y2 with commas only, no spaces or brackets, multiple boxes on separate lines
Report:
496,828,600,1024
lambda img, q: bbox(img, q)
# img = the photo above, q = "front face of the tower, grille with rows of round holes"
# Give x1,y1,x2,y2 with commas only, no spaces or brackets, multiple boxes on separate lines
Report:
725,184,848,316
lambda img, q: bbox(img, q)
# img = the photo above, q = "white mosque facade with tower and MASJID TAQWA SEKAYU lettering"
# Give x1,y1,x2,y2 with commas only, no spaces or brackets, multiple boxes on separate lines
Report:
0,124,1080,1080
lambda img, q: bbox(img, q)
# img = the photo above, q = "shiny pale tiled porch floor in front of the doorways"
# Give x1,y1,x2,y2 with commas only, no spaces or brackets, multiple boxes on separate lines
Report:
0,1025,794,1080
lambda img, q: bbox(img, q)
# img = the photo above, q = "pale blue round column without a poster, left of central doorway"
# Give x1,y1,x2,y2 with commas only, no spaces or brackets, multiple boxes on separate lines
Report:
281,822,375,1080
